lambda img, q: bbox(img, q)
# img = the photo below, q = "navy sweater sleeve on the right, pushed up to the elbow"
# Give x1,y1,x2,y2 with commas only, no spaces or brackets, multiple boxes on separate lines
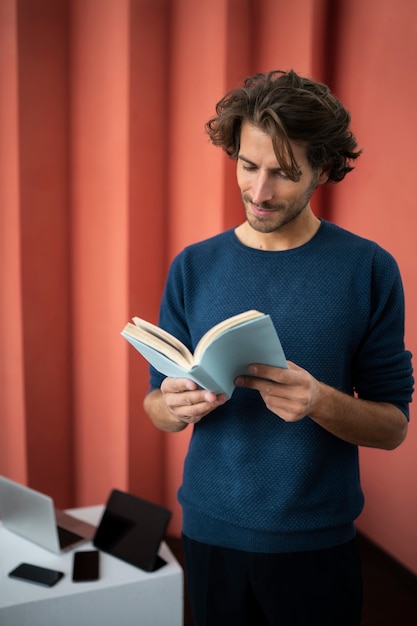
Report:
354,247,414,419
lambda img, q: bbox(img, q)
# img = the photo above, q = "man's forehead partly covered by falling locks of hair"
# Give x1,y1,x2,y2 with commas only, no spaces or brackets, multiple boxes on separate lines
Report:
239,121,308,168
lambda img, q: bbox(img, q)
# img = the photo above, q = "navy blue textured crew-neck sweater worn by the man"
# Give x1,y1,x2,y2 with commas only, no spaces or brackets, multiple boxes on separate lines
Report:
151,221,413,552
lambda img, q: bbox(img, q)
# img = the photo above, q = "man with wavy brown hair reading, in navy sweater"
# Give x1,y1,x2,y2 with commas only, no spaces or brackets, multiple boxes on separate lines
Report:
144,71,413,626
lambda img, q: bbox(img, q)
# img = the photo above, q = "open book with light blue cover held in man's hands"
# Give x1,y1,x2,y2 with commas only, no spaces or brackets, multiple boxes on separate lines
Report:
121,311,288,398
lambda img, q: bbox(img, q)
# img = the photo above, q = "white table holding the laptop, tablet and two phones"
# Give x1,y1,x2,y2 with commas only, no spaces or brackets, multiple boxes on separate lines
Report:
0,506,183,626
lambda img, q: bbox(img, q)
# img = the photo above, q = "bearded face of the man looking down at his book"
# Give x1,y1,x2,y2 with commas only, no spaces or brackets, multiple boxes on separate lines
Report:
237,122,327,233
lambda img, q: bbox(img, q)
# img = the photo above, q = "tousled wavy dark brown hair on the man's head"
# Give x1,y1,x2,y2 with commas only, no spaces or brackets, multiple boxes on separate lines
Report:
205,70,362,183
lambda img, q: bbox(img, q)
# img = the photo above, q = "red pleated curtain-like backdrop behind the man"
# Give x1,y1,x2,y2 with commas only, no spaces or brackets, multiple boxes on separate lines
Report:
0,0,417,572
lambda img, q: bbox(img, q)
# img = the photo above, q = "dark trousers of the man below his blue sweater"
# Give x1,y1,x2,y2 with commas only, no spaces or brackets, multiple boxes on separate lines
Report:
182,535,362,626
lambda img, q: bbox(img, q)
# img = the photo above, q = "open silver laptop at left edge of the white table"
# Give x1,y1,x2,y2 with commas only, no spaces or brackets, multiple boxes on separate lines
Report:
0,476,96,554
